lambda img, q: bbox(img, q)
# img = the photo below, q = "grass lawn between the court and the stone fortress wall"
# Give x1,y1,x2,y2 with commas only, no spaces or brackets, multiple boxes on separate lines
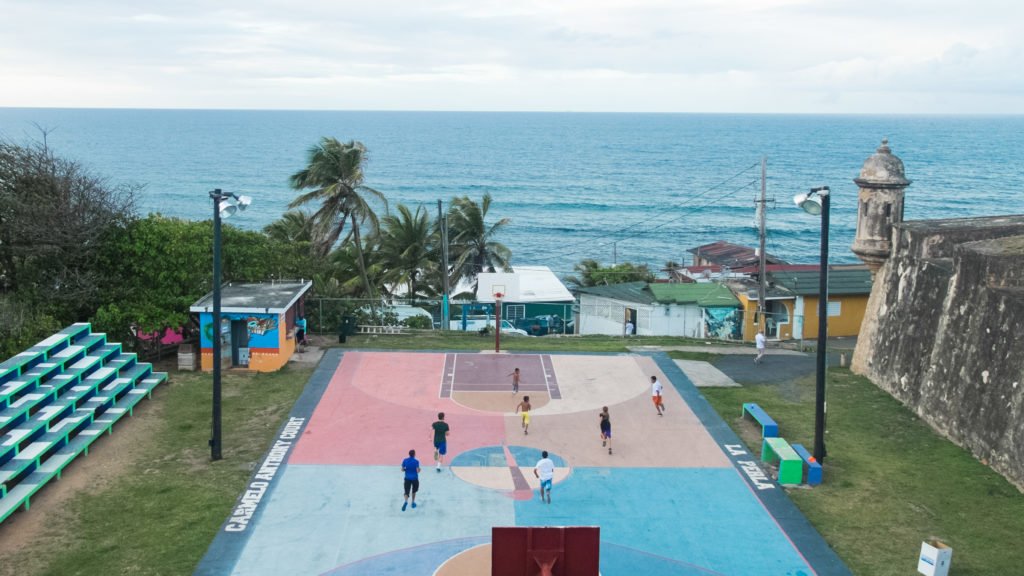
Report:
701,368,1024,576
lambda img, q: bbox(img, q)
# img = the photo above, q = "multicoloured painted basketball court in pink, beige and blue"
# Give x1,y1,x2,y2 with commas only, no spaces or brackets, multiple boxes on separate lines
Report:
197,351,849,576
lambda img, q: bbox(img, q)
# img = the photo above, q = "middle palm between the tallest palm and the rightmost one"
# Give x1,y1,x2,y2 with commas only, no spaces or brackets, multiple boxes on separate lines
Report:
381,204,437,298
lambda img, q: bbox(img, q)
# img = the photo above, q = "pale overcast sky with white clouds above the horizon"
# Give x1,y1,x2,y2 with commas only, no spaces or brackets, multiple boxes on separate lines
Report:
0,0,1024,114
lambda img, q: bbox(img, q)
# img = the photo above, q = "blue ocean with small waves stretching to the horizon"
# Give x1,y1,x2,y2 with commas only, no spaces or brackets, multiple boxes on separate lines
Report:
0,109,1024,276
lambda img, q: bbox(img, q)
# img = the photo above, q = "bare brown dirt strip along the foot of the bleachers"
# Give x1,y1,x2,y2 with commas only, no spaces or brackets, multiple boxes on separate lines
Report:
0,388,163,576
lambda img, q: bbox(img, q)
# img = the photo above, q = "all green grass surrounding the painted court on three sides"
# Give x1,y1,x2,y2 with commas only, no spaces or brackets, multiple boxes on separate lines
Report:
0,332,1024,576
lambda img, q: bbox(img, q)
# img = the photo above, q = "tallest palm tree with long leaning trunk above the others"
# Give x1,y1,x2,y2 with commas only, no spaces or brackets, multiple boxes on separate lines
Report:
288,136,387,297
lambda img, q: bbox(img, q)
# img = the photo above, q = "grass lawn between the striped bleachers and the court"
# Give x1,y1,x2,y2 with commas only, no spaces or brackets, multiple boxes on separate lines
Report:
0,368,312,576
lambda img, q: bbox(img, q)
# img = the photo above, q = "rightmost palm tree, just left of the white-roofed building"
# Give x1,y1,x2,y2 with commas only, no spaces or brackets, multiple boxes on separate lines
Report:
449,194,512,286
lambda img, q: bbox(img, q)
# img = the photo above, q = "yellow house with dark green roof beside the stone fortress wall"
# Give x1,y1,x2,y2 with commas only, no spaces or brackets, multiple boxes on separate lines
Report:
729,264,871,341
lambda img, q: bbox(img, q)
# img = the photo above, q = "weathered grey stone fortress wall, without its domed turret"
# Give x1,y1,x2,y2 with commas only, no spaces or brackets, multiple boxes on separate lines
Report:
852,215,1024,490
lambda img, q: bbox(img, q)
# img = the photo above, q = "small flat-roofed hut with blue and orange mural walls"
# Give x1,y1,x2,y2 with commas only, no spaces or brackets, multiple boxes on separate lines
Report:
188,280,312,372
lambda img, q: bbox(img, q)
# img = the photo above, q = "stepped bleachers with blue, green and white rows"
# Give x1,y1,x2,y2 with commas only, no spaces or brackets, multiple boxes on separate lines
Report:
0,323,167,522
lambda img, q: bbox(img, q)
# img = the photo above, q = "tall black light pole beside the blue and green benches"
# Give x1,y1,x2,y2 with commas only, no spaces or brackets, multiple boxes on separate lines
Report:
793,186,830,462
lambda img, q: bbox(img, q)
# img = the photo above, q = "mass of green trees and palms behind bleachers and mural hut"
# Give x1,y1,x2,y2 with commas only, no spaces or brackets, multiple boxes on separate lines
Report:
0,138,511,356
